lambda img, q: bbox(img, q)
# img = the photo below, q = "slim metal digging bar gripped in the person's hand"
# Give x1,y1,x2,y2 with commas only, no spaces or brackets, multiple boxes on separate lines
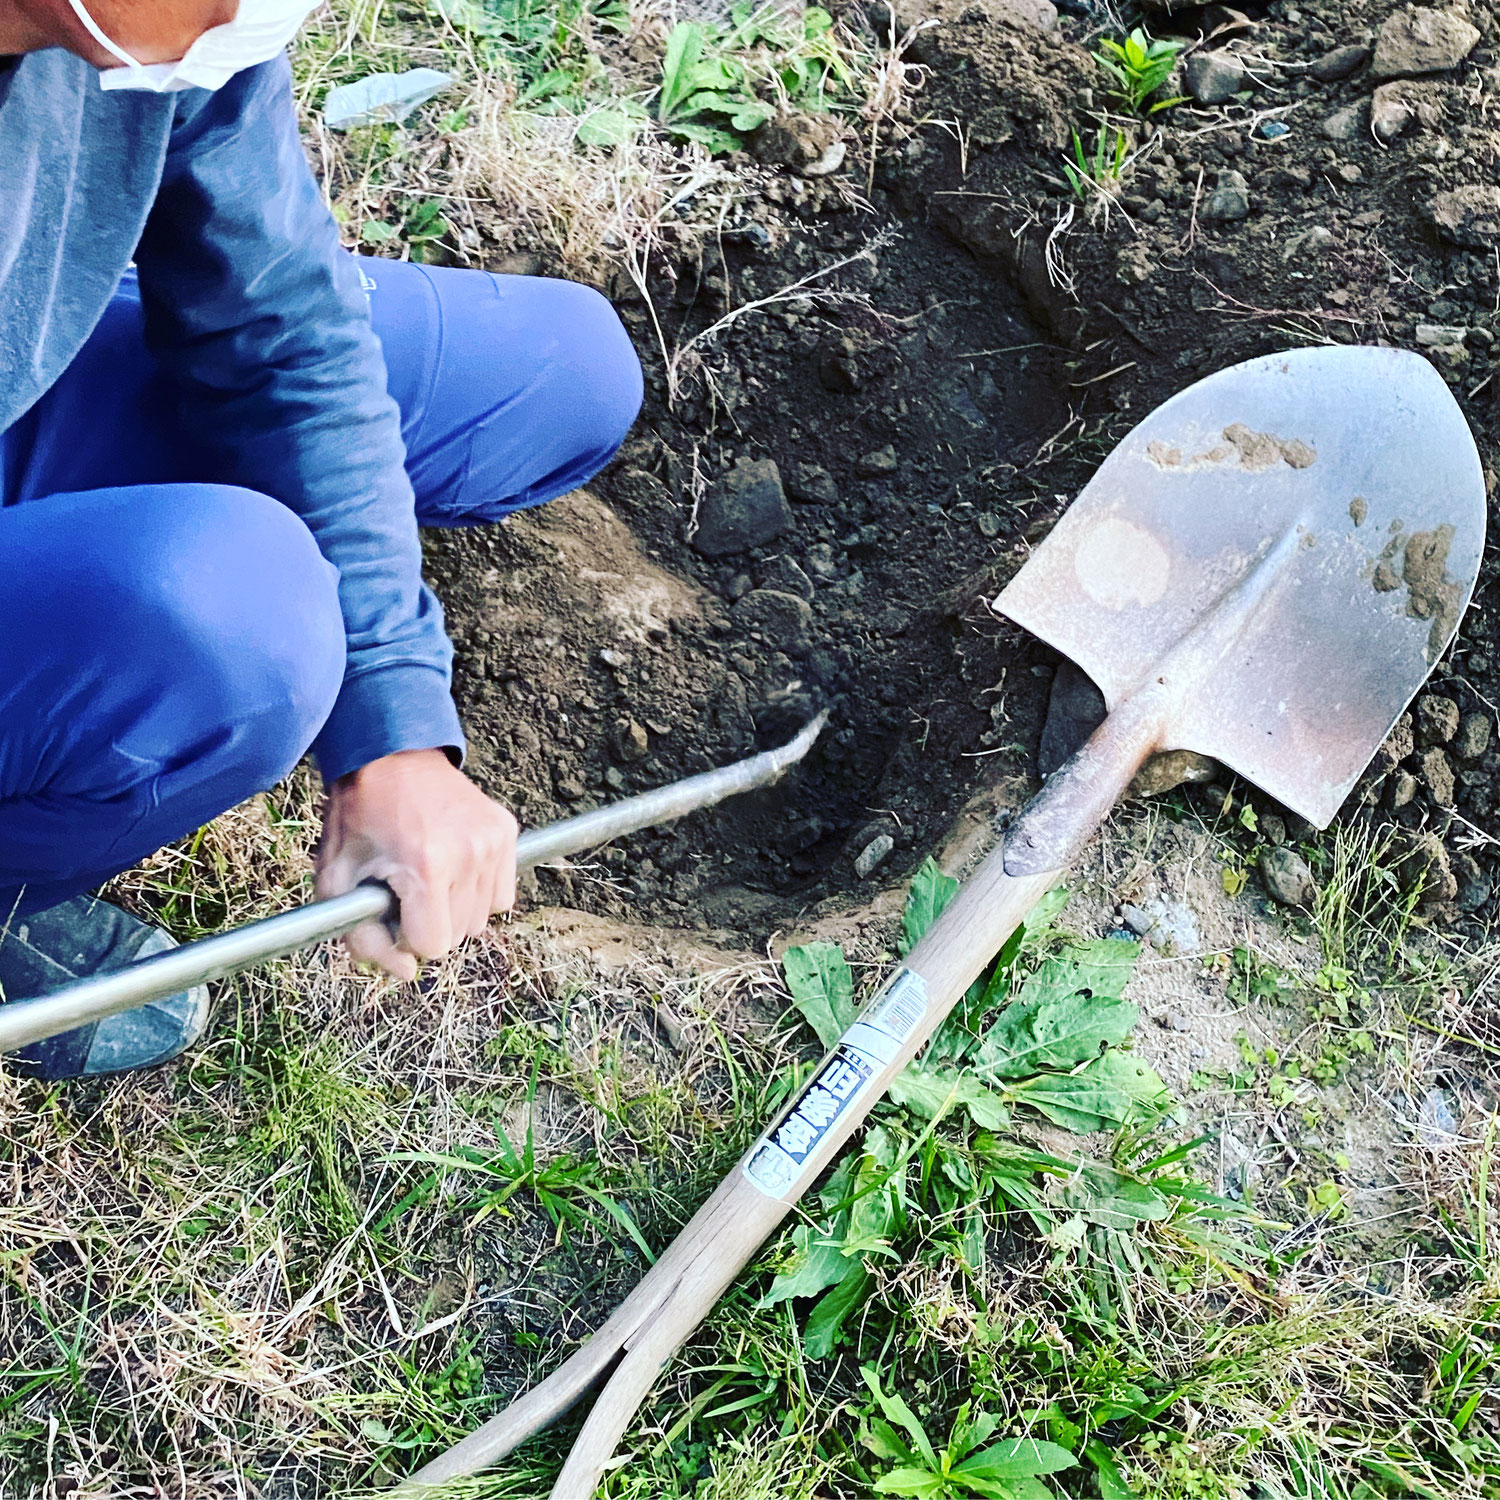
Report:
0,713,828,1053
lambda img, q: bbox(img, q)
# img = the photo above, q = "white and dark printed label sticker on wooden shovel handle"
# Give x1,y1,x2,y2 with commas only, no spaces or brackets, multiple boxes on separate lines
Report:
744,969,927,1199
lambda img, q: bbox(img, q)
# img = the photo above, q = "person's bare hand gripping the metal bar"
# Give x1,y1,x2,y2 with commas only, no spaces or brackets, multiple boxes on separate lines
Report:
318,750,516,980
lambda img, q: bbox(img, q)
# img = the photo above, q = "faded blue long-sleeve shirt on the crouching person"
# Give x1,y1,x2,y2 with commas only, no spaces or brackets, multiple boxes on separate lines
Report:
0,50,462,780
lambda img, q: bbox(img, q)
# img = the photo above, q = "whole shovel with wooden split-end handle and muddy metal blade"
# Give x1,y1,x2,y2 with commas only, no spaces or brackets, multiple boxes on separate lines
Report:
399,348,1485,1500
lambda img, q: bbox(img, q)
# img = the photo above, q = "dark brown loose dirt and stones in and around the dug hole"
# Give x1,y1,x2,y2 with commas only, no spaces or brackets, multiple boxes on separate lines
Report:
431,0,1500,932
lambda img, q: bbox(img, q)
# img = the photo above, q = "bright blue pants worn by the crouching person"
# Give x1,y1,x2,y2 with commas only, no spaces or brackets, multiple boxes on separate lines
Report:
0,261,641,923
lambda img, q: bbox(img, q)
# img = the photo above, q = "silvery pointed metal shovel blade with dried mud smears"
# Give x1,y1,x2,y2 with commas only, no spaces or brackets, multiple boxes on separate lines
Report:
995,347,1485,828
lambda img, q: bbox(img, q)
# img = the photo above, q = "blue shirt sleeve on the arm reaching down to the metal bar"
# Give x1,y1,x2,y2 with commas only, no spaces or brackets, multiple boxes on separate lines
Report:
137,57,464,782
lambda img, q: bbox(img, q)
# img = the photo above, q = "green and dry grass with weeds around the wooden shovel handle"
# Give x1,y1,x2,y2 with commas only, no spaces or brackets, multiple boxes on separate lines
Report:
0,785,1500,1500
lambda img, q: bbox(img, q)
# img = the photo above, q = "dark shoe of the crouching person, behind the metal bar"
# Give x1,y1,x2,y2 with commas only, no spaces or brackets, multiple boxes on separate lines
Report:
0,896,209,1082
